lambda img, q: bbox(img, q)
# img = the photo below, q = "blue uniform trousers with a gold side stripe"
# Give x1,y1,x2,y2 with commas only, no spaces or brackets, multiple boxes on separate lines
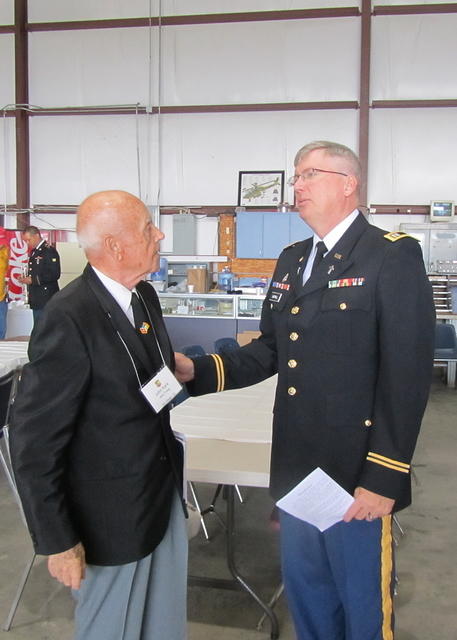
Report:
280,510,394,640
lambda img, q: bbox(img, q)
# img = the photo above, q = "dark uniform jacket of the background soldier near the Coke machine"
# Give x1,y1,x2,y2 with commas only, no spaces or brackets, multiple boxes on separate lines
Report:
28,241,60,309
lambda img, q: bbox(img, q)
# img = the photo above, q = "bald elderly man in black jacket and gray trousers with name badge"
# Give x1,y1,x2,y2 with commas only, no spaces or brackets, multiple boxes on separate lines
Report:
11,191,187,640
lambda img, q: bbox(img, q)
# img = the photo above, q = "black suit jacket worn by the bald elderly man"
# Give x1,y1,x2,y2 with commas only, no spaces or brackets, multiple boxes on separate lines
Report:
10,266,182,565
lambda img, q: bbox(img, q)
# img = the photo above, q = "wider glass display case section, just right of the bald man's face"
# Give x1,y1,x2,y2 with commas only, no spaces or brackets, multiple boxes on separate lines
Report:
159,293,235,318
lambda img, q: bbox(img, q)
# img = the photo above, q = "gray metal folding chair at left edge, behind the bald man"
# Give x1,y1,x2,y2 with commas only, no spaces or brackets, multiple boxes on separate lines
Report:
0,369,36,631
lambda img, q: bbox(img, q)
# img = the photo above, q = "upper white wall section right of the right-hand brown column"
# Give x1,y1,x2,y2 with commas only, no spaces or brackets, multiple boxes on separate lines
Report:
371,13,457,100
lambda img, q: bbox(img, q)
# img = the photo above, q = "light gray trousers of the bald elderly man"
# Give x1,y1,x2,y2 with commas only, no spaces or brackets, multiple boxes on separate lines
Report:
73,494,187,640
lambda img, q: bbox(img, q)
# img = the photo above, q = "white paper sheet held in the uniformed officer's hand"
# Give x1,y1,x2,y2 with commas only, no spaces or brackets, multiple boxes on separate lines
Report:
276,467,354,531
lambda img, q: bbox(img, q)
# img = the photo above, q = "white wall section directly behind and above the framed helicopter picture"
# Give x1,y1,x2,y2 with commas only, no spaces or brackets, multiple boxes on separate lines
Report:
160,110,358,206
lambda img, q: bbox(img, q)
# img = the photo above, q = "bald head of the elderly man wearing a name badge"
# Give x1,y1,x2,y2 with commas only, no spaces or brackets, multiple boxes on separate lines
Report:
76,191,164,288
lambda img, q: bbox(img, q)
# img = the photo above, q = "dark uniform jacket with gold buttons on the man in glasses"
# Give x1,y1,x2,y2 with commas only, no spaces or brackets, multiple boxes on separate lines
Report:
189,214,435,509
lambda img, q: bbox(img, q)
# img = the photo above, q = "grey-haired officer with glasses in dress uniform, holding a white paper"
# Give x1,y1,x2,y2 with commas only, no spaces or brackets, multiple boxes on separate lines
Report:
177,141,435,640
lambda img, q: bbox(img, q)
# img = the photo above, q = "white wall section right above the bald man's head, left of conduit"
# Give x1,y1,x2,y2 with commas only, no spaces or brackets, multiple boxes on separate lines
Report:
30,116,157,204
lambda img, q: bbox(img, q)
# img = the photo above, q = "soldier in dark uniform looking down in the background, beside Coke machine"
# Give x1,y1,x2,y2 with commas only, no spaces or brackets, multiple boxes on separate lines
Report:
19,226,60,323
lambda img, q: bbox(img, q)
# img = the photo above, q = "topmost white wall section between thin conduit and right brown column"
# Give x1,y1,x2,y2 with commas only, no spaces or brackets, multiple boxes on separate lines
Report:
162,18,360,105
